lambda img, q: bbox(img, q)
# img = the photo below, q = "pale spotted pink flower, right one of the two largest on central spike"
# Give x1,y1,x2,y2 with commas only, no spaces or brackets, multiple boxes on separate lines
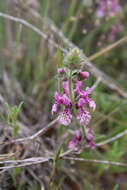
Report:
77,108,91,125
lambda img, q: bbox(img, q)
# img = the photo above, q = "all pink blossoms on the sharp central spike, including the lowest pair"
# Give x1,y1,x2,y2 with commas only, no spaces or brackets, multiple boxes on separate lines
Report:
51,63,96,148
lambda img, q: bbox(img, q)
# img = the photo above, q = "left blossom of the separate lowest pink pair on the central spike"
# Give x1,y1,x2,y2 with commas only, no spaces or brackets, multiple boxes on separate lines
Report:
68,130,81,149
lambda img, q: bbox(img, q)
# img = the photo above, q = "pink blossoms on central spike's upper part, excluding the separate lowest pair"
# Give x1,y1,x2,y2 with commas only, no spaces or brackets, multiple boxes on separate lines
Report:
52,69,96,126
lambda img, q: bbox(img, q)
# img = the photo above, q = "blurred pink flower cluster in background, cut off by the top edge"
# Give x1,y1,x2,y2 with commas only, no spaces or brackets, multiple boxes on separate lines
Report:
96,0,121,18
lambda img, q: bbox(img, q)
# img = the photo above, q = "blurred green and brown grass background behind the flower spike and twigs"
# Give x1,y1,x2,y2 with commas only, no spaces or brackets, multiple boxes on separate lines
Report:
0,0,127,190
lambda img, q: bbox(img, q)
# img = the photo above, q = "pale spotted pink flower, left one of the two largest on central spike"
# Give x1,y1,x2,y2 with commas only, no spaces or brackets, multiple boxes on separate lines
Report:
59,108,72,126
